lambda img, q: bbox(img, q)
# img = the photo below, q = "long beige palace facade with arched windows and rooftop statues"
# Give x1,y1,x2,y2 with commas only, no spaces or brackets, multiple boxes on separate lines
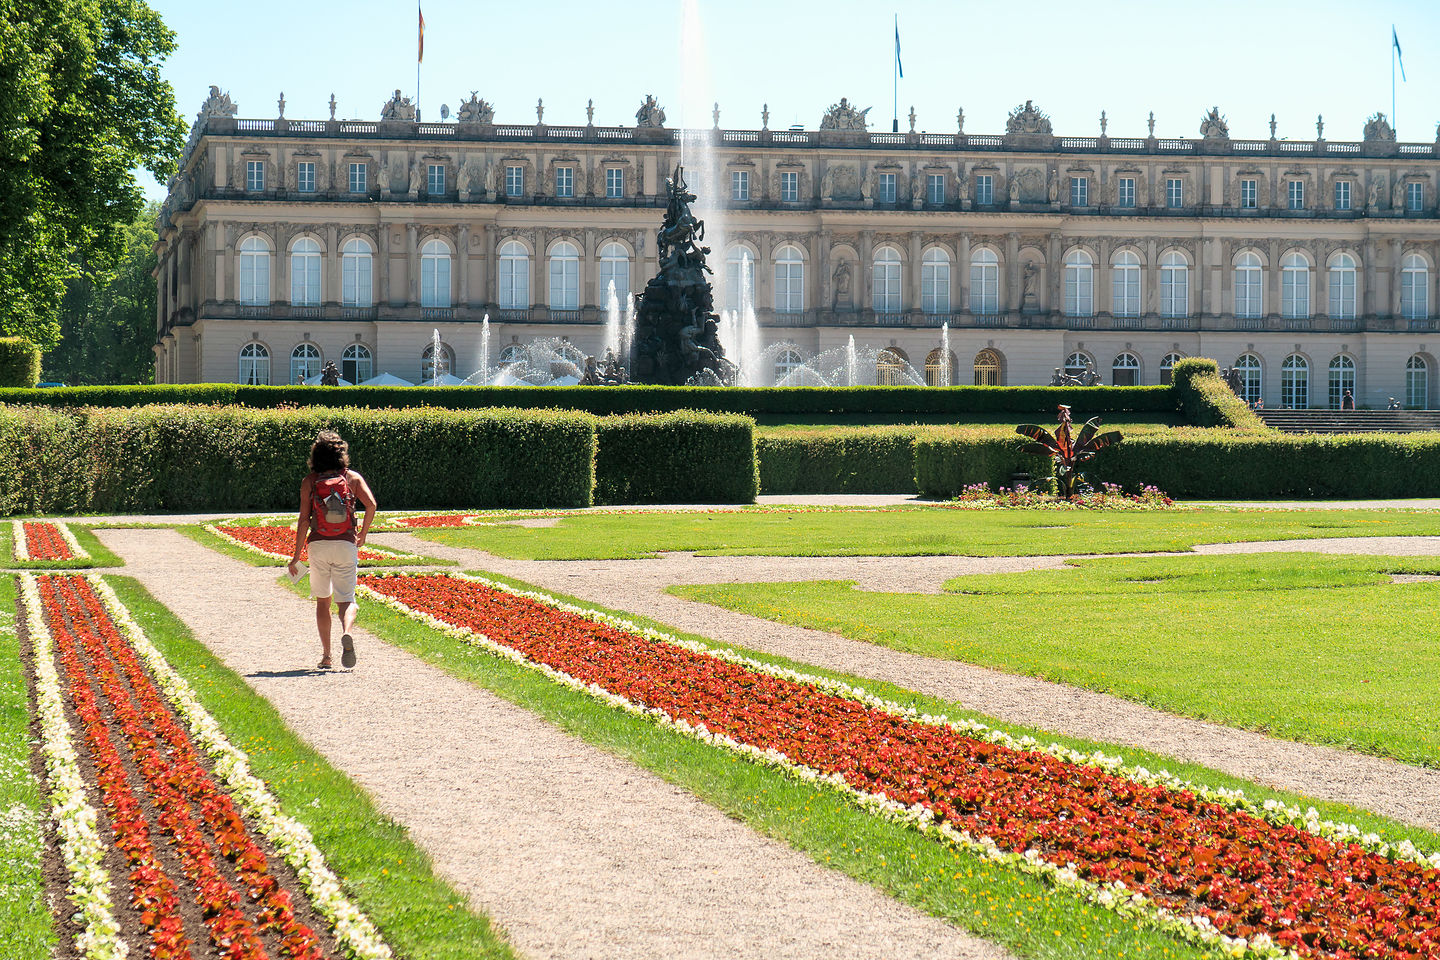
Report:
156,88,1440,407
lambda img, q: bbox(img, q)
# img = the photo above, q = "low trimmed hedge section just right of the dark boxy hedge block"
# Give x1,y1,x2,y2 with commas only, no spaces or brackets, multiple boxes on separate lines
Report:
755,427,914,494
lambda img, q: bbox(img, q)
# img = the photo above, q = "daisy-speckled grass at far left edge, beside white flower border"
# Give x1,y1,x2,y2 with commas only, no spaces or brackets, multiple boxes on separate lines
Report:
0,577,56,960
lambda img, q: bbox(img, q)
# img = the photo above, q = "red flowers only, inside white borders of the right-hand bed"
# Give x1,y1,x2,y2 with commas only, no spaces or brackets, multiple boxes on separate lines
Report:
361,576,1440,960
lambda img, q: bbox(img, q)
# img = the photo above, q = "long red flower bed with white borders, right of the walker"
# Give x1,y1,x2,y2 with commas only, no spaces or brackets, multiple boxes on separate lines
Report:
361,576,1440,960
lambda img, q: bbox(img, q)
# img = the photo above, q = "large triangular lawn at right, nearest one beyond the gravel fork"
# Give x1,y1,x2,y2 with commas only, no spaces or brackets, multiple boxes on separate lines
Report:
671,554,1440,766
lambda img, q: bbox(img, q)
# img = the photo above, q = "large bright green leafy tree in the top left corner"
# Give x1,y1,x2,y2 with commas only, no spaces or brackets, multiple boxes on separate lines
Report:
0,0,184,350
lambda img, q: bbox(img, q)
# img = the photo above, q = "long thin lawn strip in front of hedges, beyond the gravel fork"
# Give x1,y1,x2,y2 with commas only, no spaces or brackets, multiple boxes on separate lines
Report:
415,507,1440,560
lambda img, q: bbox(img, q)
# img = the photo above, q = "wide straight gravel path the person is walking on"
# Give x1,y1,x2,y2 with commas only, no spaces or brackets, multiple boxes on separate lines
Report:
99,530,1009,960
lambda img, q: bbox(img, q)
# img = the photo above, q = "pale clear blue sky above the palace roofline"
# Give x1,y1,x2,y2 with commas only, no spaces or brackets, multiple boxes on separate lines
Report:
143,0,1440,197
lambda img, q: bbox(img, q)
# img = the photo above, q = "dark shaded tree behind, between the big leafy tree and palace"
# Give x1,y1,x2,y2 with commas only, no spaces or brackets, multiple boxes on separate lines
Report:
45,203,160,383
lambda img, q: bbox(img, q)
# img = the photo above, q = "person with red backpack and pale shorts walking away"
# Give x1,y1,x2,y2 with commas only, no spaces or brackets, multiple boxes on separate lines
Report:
289,430,376,669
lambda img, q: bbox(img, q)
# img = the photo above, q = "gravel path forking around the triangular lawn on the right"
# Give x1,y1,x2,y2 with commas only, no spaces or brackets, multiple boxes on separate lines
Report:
376,534,1440,830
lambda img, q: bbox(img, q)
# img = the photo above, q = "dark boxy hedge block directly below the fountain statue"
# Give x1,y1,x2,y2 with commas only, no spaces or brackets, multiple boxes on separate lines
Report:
595,410,759,504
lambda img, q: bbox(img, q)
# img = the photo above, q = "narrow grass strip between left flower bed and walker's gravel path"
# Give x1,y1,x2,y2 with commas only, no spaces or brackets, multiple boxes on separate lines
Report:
108,577,514,960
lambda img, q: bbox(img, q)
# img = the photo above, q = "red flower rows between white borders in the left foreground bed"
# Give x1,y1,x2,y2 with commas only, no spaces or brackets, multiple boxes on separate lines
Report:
39,576,324,960
